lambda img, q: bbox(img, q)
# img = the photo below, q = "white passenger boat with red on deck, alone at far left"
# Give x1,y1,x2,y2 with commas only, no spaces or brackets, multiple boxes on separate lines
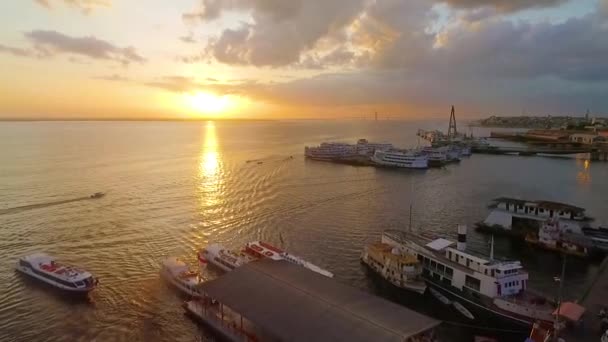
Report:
16,253,99,293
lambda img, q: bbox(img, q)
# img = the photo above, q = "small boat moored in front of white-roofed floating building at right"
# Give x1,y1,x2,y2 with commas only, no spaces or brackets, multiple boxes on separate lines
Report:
525,219,592,257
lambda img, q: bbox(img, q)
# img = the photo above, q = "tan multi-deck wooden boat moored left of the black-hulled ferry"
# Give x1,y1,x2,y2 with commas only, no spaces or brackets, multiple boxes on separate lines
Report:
361,242,426,294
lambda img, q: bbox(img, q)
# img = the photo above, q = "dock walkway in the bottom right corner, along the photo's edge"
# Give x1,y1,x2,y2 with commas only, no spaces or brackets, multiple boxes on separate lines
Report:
562,257,608,342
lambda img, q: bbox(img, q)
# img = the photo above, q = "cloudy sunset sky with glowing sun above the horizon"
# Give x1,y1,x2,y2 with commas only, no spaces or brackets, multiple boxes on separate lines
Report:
0,0,608,119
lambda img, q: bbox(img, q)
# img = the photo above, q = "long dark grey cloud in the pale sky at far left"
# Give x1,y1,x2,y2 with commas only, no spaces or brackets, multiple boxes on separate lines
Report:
24,30,146,65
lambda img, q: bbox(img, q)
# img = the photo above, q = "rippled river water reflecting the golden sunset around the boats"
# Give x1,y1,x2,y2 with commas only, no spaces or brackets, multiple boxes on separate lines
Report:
0,121,608,341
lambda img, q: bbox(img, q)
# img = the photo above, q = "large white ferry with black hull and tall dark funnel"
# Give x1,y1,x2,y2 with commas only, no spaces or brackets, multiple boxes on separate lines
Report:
382,226,555,328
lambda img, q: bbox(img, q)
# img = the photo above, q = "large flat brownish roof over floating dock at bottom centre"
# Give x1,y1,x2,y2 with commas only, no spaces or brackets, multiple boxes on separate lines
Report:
200,259,440,342
